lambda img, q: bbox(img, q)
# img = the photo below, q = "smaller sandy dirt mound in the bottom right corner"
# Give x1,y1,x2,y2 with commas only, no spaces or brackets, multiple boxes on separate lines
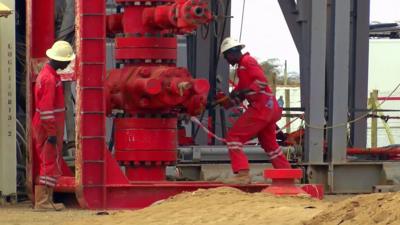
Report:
304,193,400,225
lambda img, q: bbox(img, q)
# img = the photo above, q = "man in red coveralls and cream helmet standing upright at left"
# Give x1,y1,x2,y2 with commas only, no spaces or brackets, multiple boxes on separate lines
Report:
32,41,75,211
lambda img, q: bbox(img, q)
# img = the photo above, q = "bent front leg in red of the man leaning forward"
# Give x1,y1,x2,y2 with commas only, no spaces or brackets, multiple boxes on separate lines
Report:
226,108,266,173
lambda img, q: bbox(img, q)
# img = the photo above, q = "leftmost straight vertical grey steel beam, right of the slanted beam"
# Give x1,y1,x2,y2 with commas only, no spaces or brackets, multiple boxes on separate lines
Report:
305,0,327,163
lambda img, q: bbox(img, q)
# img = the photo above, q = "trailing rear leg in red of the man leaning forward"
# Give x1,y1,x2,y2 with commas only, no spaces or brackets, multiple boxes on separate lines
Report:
258,123,291,169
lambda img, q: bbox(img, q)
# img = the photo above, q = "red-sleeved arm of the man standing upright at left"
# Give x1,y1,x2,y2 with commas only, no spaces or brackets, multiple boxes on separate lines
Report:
36,79,56,139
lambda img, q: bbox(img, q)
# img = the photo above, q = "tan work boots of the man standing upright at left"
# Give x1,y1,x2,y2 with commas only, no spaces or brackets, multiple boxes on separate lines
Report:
34,185,63,212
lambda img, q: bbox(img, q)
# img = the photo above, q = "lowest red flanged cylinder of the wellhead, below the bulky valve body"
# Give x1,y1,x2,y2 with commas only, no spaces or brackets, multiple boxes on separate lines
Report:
114,118,177,181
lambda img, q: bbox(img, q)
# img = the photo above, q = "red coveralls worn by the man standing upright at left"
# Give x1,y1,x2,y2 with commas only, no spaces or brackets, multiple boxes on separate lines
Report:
32,64,65,187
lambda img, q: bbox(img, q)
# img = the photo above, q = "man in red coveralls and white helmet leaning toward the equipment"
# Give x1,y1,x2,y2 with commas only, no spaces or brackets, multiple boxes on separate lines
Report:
217,37,290,184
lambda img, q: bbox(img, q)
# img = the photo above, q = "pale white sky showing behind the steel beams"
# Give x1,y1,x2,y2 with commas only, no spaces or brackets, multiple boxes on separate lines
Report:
231,0,400,71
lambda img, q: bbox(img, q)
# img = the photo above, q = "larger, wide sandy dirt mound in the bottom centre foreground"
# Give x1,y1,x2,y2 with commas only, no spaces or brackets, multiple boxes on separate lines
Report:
67,187,327,225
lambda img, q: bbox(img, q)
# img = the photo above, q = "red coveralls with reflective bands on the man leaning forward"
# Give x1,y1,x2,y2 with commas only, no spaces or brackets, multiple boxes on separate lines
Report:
226,53,290,173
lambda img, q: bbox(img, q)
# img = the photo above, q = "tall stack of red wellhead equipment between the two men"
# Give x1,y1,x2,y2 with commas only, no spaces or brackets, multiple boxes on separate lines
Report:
104,0,212,181
